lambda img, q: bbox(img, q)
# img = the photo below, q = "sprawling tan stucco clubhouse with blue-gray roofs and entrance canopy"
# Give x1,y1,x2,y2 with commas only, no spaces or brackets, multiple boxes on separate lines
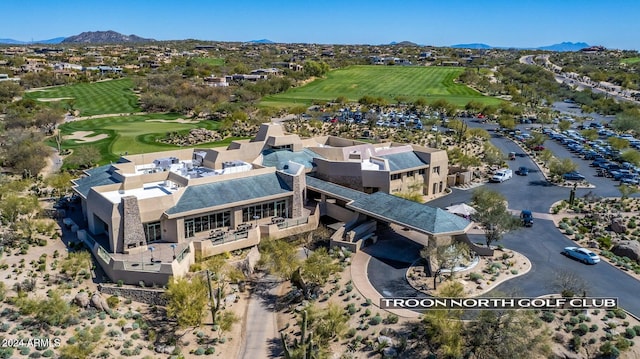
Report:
73,123,470,284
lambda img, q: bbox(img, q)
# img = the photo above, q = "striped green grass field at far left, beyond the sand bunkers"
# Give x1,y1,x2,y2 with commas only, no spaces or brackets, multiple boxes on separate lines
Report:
24,78,140,116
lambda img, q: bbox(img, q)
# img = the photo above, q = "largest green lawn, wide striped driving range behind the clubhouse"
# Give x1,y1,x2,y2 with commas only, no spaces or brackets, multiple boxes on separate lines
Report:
260,66,501,107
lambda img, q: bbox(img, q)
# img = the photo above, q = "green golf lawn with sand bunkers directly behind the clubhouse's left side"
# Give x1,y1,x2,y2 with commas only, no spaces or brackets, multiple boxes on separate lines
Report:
51,114,239,163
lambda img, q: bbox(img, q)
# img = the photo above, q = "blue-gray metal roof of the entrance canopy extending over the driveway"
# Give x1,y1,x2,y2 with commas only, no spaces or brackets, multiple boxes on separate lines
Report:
347,192,470,235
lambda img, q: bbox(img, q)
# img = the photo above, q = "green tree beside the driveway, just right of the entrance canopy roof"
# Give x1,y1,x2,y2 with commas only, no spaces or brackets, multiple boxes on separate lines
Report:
471,188,520,247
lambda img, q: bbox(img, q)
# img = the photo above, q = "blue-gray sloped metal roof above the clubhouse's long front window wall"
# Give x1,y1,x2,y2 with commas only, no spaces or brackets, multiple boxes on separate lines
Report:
166,173,291,214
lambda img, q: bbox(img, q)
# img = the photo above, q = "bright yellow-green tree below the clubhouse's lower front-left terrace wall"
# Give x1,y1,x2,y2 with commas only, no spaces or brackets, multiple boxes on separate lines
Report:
165,276,209,328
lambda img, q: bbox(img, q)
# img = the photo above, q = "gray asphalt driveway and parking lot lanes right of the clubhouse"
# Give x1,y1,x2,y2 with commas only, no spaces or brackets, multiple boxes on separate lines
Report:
365,123,640,316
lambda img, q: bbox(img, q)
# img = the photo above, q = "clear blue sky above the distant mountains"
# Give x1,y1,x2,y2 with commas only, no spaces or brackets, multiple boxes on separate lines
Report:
5,0,640,50
